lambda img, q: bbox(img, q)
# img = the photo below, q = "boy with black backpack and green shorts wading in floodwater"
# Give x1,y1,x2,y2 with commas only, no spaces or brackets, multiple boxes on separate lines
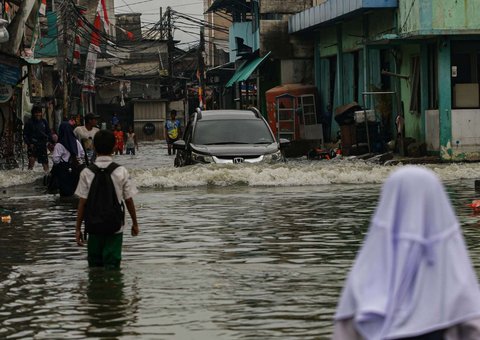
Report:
75,130,139,269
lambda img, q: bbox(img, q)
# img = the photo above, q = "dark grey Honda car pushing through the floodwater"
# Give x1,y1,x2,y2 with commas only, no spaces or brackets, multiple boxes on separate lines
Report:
173,108,290,166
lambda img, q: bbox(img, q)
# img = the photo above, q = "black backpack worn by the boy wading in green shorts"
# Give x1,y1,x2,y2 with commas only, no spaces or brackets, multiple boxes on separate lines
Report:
85,162,125,235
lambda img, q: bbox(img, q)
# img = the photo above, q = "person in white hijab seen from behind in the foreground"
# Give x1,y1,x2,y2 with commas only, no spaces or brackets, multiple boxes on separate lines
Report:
333,166,480,340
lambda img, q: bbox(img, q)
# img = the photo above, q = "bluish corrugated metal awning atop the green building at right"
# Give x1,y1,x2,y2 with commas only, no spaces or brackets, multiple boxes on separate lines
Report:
288,0,398,33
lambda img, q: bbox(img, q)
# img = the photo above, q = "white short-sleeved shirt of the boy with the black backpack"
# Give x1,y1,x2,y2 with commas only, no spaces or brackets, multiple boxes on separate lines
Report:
75,156,138,232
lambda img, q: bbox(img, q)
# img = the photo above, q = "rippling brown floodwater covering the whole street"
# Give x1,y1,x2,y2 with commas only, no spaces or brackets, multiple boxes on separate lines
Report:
0,143,480,340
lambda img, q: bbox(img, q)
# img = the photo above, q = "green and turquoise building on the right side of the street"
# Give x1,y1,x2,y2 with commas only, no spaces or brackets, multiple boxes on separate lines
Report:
289,0,480,160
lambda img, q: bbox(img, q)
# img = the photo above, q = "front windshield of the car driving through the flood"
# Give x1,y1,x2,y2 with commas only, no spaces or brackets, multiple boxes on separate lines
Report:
192,119,274,145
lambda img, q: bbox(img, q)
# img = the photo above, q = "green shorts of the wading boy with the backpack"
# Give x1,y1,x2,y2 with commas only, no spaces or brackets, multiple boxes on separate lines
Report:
87,233,123,269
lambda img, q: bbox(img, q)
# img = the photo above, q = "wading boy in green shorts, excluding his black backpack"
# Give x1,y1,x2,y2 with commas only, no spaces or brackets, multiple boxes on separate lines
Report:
75,130,139,269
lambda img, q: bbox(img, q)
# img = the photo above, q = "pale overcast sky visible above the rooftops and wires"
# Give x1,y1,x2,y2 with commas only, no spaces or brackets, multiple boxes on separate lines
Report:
115,0,203,48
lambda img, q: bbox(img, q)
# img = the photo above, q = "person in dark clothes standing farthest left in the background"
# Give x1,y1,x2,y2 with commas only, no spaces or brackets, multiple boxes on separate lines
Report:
23,105,53,174
